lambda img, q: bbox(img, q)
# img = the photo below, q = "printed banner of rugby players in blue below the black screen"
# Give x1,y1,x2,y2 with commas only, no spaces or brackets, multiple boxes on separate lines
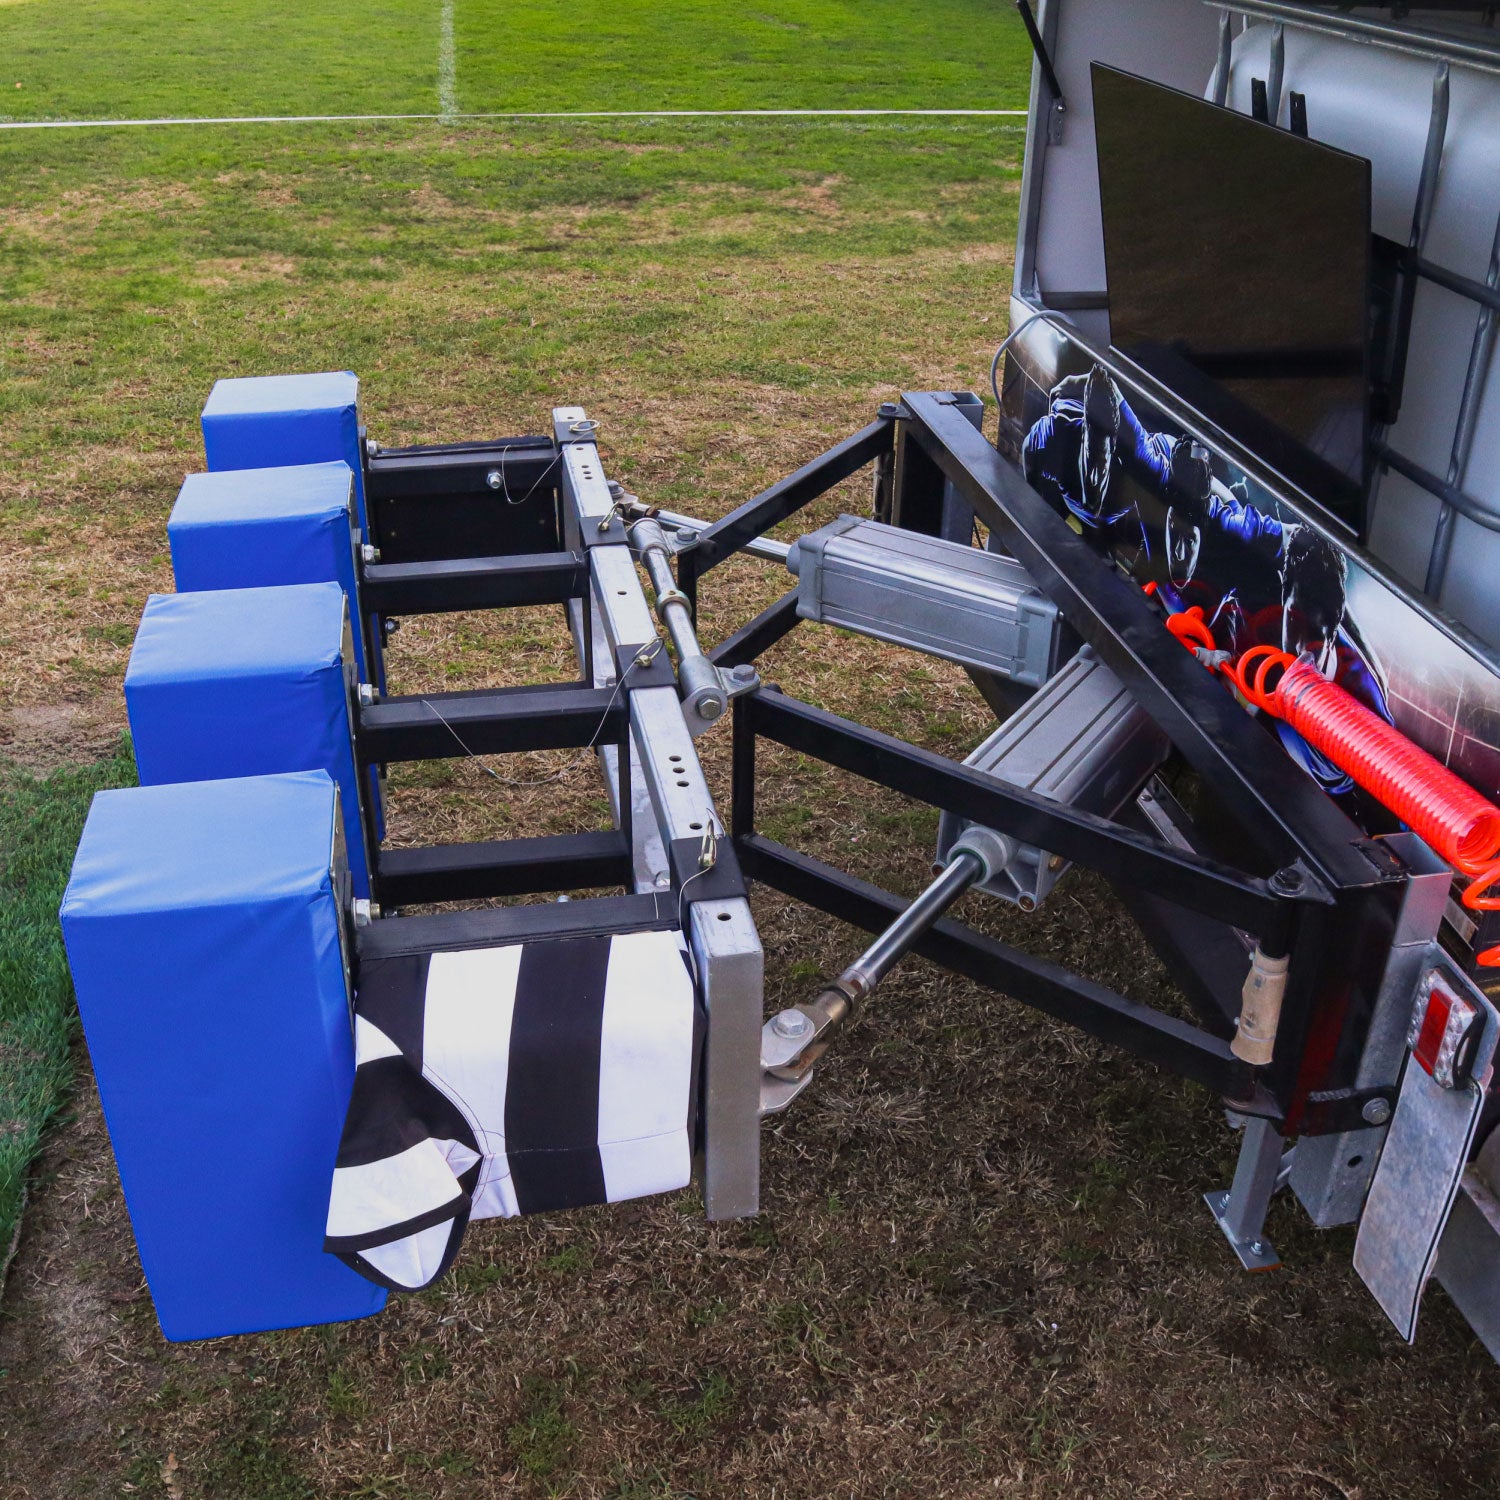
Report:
999,324,1500,831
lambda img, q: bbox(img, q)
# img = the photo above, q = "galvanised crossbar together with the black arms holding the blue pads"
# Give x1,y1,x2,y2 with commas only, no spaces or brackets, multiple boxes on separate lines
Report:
354,408,762,1218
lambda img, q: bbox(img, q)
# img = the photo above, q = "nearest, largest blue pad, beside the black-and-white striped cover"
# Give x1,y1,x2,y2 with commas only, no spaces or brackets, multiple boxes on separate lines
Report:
62,771,386,1340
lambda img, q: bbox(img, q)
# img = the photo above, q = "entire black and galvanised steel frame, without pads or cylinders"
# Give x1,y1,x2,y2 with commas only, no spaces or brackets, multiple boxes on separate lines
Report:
356,393,1431,1218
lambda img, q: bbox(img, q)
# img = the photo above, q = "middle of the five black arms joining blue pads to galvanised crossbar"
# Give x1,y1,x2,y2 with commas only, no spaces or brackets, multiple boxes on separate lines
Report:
354,687,630,765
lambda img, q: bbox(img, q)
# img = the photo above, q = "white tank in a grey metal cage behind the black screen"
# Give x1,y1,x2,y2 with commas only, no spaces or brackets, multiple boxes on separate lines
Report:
1224,11,1500,644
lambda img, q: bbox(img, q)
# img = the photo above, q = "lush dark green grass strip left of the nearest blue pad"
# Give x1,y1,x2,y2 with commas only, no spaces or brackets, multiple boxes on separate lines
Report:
0,732,135,1280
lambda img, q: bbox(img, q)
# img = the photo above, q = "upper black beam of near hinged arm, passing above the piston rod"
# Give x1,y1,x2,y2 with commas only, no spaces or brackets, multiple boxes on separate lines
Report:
756,684,1296,933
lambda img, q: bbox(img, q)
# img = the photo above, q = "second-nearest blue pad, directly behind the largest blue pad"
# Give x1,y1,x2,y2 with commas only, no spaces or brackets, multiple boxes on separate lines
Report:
125,584,369,897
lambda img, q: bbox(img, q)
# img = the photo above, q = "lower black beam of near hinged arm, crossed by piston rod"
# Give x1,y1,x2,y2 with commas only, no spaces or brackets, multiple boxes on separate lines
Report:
737,834,1260,1115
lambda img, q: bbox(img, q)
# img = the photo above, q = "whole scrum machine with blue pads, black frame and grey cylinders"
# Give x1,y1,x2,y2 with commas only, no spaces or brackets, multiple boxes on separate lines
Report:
63,366,1500,1338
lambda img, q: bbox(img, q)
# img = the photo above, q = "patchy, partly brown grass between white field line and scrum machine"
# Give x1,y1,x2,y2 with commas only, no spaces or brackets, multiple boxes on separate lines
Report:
0,120,1020,714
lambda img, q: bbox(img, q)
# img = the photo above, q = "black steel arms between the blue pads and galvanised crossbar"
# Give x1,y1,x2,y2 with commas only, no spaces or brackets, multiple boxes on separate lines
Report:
354,437,636,936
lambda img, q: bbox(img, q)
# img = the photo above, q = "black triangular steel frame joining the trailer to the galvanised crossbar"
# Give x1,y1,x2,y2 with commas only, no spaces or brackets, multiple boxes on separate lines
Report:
702,392,1409,1134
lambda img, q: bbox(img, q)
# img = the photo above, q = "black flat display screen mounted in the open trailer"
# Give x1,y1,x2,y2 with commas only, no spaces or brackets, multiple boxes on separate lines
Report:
1094,63,1371,531
